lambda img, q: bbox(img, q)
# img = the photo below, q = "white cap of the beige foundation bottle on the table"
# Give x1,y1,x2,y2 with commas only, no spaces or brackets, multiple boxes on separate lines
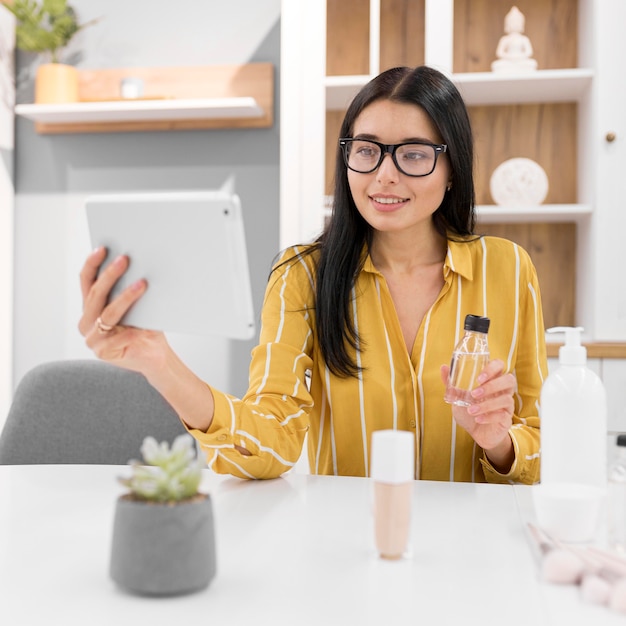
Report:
370,430,415,484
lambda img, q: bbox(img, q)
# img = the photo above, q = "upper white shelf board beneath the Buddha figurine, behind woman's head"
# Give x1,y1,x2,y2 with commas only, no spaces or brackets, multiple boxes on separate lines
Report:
326,68,593,111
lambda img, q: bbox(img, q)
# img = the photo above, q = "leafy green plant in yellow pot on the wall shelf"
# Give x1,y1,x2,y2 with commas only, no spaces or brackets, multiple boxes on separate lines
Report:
0,0,96,103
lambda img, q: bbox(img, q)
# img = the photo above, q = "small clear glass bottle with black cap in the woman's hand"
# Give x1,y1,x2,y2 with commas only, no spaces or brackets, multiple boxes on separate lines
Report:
443,315,489,406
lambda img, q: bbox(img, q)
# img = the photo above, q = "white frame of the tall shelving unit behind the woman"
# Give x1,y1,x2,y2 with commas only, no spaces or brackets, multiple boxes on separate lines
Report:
281,0,626,342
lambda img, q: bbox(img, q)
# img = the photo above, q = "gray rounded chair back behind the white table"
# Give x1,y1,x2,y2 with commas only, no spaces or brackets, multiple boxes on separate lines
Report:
0,360,185,465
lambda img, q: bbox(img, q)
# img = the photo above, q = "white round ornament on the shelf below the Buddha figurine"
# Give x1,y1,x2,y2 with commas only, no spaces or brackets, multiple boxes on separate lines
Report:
489,158,548,206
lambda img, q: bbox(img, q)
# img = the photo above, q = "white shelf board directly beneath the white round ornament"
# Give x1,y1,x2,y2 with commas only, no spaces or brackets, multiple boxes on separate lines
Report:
476,204,592,224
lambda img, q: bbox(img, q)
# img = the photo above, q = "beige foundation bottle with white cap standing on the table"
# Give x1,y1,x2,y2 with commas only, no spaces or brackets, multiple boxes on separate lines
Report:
371,430,415,559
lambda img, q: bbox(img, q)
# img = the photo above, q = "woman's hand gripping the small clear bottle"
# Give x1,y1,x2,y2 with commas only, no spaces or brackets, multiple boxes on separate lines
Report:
441,359,517,473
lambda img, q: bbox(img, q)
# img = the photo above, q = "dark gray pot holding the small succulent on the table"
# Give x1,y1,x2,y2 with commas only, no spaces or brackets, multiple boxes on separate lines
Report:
110,495,216,596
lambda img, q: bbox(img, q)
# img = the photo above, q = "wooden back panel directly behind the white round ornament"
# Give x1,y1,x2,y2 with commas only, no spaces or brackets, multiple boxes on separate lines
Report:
469,103,577,204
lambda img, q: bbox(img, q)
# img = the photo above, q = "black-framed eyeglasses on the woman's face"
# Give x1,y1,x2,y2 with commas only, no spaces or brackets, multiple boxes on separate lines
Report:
339,137,448,177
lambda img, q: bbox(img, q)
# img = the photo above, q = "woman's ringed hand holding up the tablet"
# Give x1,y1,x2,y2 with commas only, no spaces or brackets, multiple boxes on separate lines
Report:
78,247,168,375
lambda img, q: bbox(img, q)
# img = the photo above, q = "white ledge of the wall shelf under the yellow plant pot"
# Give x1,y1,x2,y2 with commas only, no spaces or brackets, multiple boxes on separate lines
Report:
15,97,264,124
